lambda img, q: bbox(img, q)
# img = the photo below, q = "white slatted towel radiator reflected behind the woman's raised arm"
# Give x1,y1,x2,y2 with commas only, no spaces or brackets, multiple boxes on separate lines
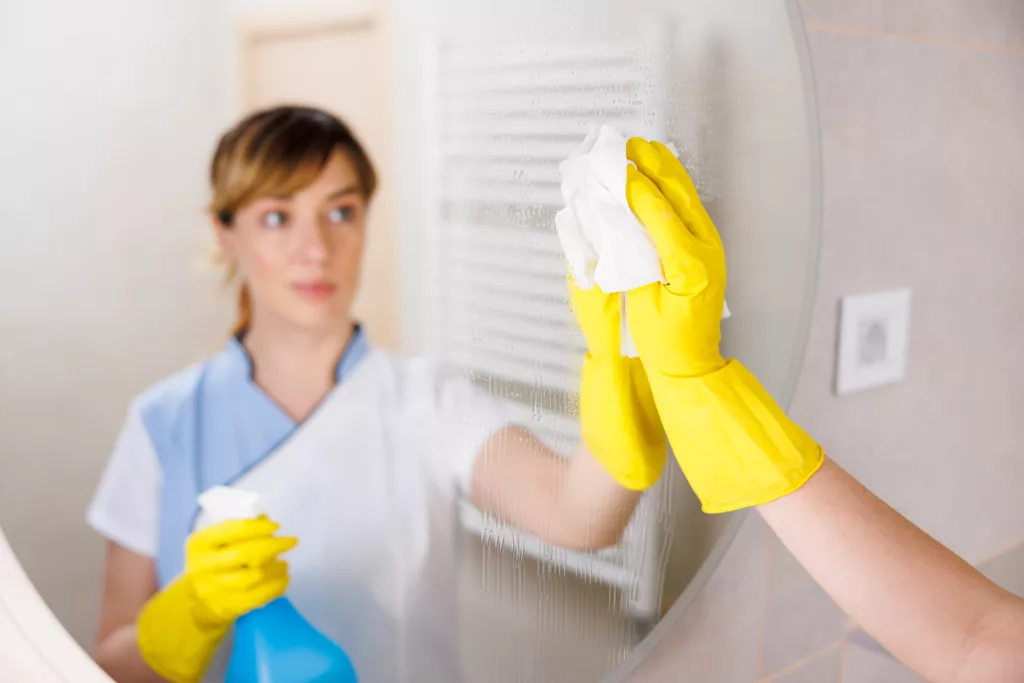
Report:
423,30,672,618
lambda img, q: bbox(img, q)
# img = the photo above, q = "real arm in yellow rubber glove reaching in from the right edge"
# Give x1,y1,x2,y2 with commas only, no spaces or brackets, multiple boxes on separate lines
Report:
614,139,1024,683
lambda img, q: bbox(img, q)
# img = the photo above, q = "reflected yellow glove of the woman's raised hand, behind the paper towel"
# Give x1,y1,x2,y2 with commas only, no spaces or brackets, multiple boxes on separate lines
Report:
569,276,668,490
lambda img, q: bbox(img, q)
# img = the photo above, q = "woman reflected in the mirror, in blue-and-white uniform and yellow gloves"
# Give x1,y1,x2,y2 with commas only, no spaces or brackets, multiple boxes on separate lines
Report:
89,106,666,683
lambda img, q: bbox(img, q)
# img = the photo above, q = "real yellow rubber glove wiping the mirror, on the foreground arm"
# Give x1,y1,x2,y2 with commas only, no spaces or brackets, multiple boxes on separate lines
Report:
626,138,824,513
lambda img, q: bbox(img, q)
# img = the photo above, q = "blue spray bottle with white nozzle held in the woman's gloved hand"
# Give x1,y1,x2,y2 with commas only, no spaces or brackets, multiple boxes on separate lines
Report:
199,486,358,683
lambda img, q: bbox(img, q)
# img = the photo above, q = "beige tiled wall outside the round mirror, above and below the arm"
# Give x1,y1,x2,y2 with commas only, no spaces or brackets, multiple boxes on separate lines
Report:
630,0,1024,683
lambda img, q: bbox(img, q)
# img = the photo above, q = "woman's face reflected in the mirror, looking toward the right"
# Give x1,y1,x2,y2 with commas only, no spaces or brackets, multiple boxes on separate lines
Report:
216,152,367,330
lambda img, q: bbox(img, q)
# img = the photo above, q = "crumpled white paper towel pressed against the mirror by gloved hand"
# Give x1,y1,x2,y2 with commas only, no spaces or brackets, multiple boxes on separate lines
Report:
555,124,730,358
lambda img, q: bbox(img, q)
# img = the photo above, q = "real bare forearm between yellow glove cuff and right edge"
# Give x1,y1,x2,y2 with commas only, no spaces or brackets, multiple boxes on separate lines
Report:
759,460,1024,683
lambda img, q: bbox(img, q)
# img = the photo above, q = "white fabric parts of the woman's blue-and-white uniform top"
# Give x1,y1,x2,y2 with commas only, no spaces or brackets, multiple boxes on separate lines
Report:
90,350,508,683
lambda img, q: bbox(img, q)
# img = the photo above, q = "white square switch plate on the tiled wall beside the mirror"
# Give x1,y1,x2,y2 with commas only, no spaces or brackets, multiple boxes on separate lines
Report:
836,289,910,395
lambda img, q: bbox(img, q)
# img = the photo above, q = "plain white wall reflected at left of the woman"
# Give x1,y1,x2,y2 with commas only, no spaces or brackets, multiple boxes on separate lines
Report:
0,0,229,642
